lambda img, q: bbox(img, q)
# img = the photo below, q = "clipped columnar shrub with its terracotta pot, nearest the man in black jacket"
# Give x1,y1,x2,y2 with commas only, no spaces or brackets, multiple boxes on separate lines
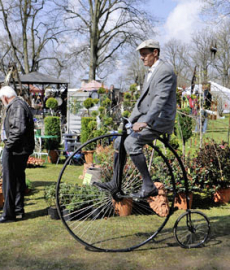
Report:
44,116,61,163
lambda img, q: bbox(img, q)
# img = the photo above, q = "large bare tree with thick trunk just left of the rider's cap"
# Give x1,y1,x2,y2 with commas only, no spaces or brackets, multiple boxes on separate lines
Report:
56,0,154,80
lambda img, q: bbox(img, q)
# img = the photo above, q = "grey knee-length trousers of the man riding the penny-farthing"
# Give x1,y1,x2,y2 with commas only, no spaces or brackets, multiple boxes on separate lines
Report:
114,128,161,155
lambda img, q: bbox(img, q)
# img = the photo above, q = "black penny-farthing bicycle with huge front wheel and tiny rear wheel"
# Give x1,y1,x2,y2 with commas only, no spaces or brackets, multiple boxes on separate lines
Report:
56,119,210,252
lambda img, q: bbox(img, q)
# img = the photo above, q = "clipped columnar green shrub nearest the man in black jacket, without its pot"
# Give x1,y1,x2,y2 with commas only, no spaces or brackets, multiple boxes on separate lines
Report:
44,116,61,150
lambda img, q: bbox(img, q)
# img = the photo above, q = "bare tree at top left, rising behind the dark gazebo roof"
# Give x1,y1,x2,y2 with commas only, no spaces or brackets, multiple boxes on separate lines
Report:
0,0,65,73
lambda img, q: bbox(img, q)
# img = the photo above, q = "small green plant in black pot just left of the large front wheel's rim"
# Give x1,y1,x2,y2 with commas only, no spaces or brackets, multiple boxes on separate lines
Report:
44,184,60,219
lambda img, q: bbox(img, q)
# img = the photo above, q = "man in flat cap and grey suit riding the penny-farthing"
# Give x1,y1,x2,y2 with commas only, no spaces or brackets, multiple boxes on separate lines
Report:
96,40,177,198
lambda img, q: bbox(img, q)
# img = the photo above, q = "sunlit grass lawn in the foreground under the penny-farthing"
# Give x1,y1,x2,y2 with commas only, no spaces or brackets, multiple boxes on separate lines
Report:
0,164,230,270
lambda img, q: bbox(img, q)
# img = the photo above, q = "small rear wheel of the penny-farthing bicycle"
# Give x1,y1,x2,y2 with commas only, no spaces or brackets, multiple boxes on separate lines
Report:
173,210,211,248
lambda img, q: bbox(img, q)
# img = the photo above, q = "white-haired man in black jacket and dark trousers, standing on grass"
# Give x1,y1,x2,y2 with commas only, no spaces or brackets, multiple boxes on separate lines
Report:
0,86,35,223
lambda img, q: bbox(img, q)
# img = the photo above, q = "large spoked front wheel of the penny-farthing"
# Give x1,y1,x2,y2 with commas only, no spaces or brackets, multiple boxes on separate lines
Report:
57,134,175,251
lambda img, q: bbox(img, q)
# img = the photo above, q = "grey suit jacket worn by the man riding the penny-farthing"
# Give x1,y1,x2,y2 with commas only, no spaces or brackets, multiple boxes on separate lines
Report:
129,60,177,134
